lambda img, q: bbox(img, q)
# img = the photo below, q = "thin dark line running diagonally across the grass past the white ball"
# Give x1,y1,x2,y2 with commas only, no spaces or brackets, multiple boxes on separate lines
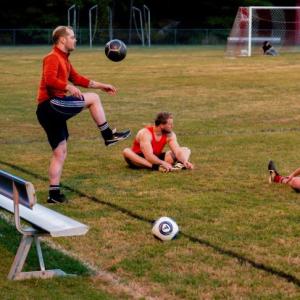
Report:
0,160,300,287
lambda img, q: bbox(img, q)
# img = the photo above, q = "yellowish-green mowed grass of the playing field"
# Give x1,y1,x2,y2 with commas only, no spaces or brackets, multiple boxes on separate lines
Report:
0,47,300,299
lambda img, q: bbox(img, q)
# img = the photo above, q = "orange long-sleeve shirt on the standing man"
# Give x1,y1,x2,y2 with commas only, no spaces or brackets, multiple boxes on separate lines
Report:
37,47,90,103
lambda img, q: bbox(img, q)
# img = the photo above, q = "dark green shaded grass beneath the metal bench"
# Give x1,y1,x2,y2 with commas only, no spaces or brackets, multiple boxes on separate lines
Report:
0,217,91,276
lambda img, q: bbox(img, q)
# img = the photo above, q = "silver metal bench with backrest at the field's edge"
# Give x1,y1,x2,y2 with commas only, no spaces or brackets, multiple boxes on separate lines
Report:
0,170,88,280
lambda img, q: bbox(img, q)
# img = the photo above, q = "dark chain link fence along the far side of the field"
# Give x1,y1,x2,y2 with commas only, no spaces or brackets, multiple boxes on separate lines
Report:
0,28,230,46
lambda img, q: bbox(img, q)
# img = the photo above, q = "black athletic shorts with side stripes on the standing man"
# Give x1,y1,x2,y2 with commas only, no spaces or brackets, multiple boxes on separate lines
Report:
36,96,84,150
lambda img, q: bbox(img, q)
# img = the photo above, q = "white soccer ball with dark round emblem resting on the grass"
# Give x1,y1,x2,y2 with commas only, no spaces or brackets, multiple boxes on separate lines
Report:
152,217,179,241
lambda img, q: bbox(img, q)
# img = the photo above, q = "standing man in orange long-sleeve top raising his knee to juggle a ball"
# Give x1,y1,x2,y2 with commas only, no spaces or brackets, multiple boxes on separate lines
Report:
36,26,130,203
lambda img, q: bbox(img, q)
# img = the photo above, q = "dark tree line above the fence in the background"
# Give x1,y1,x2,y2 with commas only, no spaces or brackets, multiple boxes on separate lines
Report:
0,0,297,28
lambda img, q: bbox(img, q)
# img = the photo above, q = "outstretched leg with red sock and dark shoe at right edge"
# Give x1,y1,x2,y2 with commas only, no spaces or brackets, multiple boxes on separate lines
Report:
268,160,300,193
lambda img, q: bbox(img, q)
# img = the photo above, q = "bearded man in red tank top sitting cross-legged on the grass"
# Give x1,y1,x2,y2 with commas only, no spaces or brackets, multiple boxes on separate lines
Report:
123,112,194,172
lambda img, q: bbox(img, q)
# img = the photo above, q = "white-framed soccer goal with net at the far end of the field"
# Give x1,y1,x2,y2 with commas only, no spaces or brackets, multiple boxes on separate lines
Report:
226,6,300,56
